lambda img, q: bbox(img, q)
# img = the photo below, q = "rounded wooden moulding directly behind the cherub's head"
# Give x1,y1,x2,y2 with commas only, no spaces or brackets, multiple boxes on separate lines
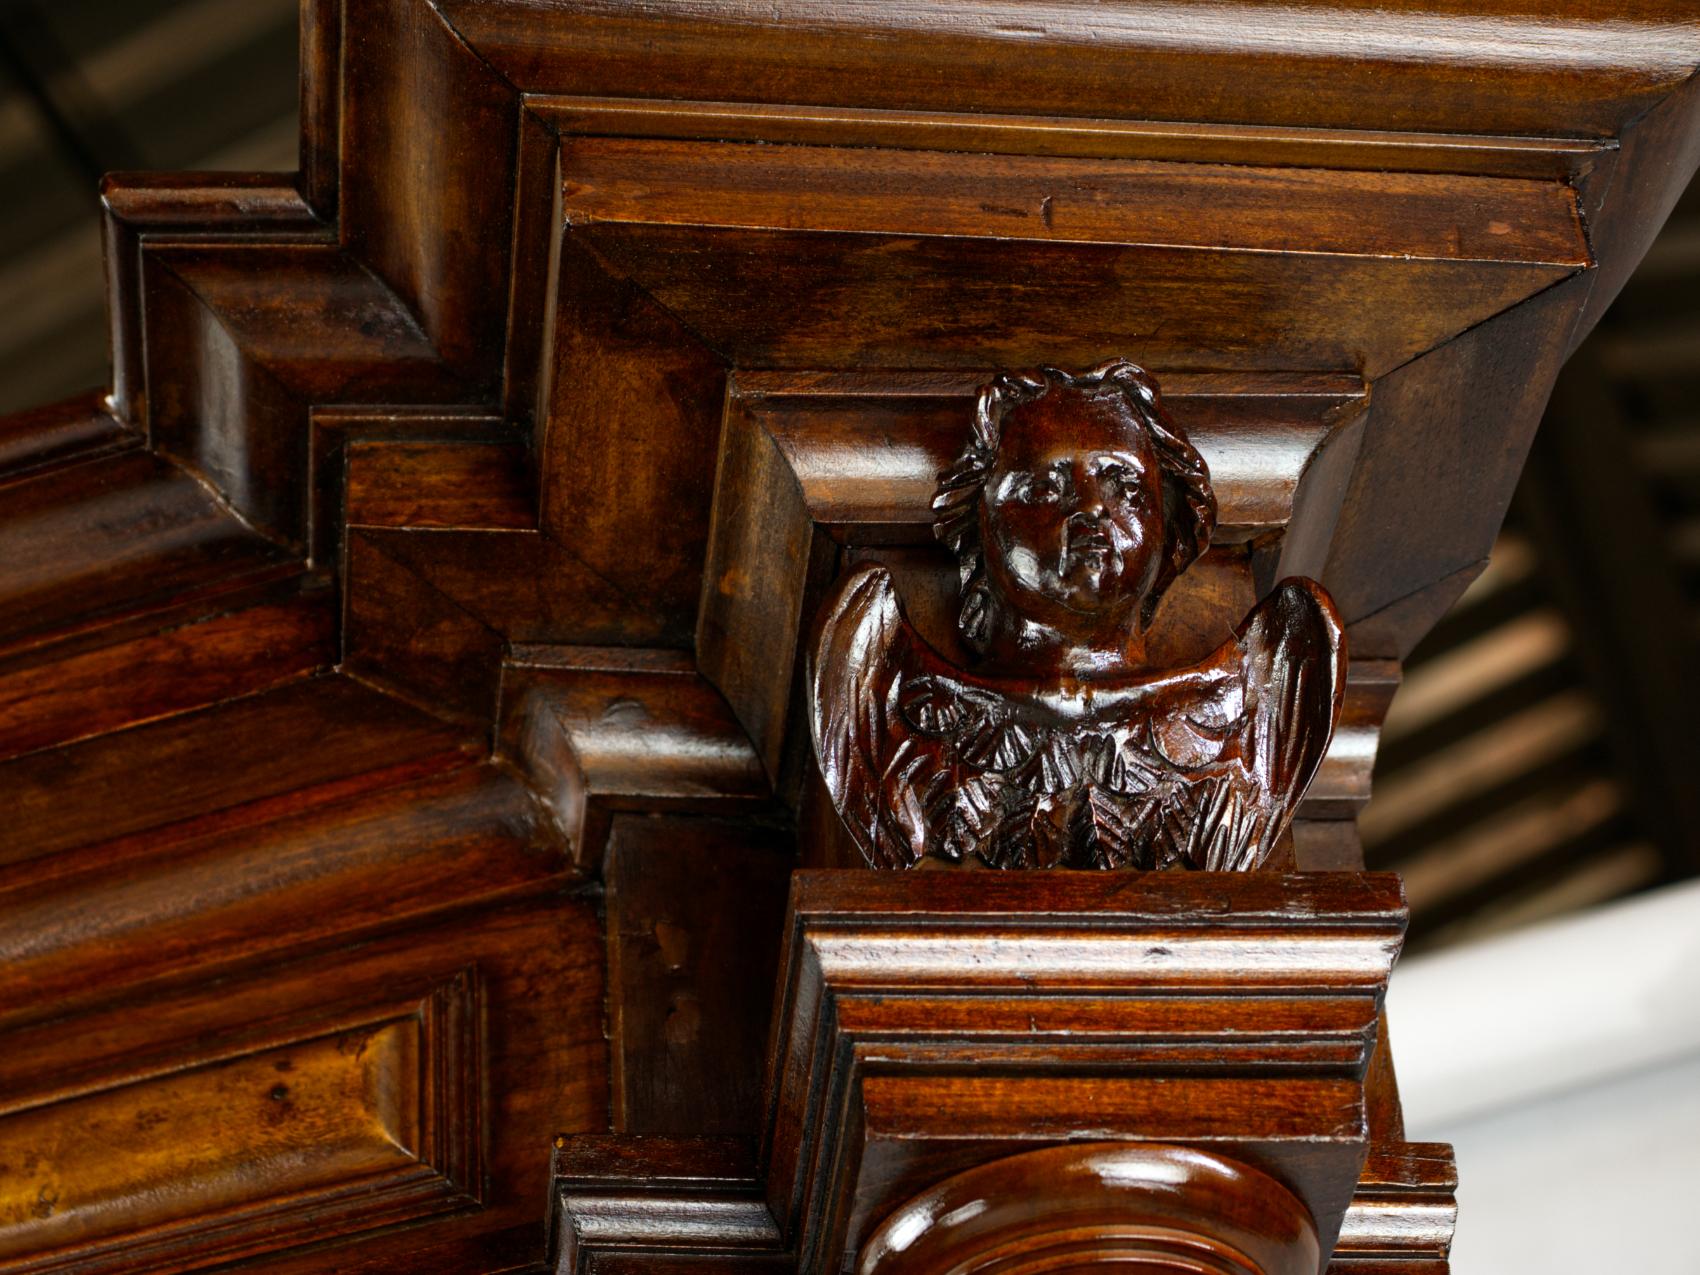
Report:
697,363,1365,791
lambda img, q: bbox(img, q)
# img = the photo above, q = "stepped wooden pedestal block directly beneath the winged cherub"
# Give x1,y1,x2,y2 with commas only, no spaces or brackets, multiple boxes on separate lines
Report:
554,872,1404,1273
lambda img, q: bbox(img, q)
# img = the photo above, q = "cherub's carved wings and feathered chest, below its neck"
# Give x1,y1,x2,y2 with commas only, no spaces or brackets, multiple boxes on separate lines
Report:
809,566,1345,870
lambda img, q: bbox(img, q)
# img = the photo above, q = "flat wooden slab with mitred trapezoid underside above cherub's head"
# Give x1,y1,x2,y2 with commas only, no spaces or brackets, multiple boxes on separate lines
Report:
563,138,1591,374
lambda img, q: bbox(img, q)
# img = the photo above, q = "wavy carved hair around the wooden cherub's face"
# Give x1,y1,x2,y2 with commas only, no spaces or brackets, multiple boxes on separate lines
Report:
933,359,1216,651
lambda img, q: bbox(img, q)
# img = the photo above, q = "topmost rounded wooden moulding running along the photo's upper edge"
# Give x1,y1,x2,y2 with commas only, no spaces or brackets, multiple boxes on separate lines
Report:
442,0,1700,136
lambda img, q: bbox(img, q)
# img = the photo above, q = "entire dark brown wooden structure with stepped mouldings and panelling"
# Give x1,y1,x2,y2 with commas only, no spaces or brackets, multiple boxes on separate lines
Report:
0,0,1700,1275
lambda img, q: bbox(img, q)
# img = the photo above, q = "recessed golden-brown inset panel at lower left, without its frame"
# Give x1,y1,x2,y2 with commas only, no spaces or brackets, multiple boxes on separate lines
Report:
0,976,479,1272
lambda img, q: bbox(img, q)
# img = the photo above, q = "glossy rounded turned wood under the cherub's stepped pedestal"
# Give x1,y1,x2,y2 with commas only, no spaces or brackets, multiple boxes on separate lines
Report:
857,1142,1323,1275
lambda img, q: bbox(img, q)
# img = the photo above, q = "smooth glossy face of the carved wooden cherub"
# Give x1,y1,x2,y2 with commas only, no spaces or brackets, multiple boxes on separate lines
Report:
981,386,1163,629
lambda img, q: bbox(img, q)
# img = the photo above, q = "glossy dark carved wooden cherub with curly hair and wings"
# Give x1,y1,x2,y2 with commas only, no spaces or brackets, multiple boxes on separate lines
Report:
809,359,1346,870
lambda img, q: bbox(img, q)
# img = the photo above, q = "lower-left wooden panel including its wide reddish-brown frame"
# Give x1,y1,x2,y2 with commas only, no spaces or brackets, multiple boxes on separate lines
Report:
0,899,607,1272
